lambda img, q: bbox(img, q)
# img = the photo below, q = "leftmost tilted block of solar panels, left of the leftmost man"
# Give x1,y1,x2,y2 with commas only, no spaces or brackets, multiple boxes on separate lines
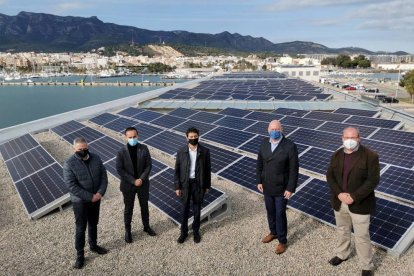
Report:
0,134,70,219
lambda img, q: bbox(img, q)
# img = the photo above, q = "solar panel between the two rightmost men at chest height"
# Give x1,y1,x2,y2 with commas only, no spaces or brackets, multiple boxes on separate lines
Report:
299,148,333,175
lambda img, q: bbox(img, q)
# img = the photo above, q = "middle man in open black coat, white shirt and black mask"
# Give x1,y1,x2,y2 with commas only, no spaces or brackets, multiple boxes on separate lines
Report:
174,127,211,243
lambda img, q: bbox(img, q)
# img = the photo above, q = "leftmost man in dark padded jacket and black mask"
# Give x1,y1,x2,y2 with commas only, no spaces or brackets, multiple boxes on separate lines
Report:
63,137,108,269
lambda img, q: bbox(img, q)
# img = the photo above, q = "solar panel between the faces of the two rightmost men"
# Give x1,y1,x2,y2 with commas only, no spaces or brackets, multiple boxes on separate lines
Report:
288,128,342,151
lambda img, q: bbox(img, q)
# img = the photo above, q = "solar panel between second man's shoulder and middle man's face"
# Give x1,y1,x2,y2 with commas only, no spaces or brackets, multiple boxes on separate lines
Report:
145,131,187,155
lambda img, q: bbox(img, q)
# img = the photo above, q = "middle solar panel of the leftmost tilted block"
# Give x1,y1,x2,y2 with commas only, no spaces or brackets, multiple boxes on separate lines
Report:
5,146,56,182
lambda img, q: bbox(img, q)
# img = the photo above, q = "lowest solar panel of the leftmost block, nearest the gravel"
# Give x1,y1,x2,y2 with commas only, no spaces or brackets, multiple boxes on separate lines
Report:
15,163,69,214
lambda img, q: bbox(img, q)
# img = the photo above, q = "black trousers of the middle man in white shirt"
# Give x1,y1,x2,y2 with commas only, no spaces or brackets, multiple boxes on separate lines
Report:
181,179,202,233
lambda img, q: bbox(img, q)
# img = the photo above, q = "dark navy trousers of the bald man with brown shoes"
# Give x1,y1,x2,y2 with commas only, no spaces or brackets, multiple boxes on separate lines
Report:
264,194,287,244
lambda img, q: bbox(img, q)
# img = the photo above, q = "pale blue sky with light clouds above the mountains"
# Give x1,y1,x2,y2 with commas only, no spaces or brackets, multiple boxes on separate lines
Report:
0,0,414,54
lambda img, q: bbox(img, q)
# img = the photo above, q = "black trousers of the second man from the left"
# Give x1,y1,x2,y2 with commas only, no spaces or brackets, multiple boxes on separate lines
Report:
122,186,149,231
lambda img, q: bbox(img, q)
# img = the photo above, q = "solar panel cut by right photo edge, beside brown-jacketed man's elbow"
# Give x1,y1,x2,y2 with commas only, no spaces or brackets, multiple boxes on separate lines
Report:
376,166,414,203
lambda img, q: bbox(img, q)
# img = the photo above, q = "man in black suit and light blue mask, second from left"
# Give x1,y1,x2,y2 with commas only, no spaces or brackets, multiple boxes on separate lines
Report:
116,127,156,243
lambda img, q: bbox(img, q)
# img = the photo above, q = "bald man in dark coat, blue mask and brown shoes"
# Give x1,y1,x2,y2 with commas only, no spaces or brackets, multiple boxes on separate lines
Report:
256,120,299,254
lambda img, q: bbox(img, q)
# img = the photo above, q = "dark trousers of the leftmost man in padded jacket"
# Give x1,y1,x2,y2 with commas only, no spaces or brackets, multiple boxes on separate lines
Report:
72,201,101,256
